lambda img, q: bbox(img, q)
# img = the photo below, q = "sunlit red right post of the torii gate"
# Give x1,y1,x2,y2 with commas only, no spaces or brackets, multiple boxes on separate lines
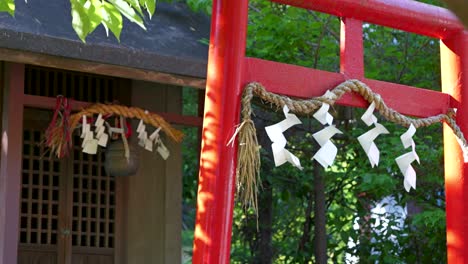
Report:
441,32,468,264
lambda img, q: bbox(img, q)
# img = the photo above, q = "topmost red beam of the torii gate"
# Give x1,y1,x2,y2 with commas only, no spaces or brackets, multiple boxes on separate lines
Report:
271,0,463,39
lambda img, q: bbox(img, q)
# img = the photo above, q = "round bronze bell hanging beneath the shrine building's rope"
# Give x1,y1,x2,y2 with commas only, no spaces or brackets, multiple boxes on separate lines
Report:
104,139,138,177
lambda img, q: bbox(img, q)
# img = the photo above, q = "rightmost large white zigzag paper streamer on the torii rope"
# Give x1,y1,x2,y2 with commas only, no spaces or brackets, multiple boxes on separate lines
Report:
395,124,419,192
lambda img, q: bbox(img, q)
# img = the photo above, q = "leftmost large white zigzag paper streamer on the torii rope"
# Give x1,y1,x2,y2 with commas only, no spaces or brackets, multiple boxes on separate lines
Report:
265,105,302,170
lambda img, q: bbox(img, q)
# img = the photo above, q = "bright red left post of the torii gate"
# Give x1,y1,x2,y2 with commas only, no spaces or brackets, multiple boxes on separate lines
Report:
192,0,248,263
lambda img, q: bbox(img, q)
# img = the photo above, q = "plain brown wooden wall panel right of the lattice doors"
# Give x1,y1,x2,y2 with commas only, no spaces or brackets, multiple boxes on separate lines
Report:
126,81,182,264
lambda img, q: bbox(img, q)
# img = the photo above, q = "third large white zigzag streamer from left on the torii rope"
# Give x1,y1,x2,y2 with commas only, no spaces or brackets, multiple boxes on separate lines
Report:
358,102,390,167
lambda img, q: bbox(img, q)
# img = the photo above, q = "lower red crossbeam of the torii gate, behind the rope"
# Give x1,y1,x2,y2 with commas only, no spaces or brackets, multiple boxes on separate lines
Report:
243,58,450,117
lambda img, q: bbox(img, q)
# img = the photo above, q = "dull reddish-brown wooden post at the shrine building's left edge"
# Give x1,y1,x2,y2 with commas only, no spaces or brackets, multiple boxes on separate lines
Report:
0,63,24,264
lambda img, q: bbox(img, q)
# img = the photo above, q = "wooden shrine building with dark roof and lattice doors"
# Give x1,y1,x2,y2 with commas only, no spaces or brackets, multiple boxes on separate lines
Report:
0,0,210,264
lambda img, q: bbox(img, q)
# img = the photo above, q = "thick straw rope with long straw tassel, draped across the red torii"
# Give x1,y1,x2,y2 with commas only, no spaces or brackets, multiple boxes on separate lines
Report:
237,80,468,211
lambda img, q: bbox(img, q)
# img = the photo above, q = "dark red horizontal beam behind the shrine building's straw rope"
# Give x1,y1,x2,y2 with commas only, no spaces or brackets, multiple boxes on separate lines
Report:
23,94,203,127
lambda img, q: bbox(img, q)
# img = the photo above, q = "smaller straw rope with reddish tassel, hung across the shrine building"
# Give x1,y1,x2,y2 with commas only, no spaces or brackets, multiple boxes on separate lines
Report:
48,104,183,157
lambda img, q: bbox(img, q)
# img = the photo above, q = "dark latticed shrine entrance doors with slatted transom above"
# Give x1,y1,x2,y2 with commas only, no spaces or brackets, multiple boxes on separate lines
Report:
18,66,125,264
